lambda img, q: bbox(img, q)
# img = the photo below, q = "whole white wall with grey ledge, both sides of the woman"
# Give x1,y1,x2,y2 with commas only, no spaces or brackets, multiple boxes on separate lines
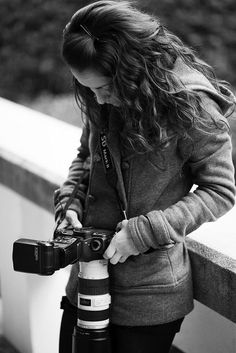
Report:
0,99,236,353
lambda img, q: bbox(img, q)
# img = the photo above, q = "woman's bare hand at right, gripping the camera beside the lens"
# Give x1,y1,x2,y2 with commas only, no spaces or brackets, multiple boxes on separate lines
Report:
103,220,139,265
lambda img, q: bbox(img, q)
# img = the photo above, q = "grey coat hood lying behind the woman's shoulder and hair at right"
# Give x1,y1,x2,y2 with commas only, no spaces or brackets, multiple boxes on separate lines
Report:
173,58,236,118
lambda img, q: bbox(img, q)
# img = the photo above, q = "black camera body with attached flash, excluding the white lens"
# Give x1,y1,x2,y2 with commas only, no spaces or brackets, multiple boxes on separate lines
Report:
13,227,114,276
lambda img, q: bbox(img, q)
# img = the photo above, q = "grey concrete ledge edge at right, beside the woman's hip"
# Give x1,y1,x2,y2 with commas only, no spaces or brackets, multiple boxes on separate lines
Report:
187,238,236,323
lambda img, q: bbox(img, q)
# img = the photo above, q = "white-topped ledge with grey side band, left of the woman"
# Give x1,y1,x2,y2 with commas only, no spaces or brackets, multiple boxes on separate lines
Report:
0,97,81,211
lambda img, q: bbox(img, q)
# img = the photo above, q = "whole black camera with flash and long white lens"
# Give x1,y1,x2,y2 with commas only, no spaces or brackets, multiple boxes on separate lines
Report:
13,227,114,353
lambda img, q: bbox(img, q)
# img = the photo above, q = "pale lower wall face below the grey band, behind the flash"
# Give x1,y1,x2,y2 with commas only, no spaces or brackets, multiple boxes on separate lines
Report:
0,185,69,353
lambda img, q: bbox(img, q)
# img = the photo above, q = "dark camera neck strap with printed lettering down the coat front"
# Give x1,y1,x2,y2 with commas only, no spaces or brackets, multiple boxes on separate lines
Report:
99,130,127,219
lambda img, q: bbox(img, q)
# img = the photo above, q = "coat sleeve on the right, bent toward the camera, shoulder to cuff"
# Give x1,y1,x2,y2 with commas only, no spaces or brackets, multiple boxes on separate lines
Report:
129,93,235,253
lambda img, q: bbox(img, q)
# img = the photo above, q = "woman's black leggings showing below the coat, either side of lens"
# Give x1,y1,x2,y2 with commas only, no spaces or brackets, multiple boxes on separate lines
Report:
59,297,183,353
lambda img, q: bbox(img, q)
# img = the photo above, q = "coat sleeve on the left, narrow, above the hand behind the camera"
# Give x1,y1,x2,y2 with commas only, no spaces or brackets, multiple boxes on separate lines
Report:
54,124,90,219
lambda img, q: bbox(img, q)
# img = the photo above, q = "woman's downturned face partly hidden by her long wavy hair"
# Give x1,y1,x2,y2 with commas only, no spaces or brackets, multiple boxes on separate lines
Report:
71,68,120,107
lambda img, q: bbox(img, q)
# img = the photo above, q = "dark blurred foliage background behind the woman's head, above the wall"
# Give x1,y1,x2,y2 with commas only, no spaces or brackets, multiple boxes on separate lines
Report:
0,0,236,125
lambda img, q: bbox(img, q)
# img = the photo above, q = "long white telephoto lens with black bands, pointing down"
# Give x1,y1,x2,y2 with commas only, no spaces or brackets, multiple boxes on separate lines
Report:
72,259,111,353
